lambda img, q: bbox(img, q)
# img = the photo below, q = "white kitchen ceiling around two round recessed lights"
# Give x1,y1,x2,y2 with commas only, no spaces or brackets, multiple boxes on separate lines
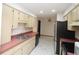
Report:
18,3,72,17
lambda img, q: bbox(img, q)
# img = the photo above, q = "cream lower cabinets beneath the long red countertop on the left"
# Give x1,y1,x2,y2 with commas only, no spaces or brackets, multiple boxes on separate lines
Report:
2,37,35,55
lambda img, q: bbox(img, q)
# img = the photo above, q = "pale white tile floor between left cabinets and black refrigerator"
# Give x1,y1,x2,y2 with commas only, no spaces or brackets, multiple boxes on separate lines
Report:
30,36,54,55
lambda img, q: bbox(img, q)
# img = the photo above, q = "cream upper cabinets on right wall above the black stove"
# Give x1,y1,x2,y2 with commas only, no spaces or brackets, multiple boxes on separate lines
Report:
64,5,79,30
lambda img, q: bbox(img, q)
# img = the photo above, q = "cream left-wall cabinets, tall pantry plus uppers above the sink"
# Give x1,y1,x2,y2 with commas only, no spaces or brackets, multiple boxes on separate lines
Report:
0,4,35,44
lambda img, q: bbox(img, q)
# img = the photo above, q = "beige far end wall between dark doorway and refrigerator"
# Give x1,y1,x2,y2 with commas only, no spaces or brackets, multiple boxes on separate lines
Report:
40,16,56,36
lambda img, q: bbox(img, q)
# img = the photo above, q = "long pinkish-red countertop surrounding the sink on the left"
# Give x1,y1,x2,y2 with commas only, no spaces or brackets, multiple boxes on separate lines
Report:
0,32,36,54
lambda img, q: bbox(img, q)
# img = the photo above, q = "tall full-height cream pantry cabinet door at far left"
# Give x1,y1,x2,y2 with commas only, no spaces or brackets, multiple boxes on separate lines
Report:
1,4,13,44
